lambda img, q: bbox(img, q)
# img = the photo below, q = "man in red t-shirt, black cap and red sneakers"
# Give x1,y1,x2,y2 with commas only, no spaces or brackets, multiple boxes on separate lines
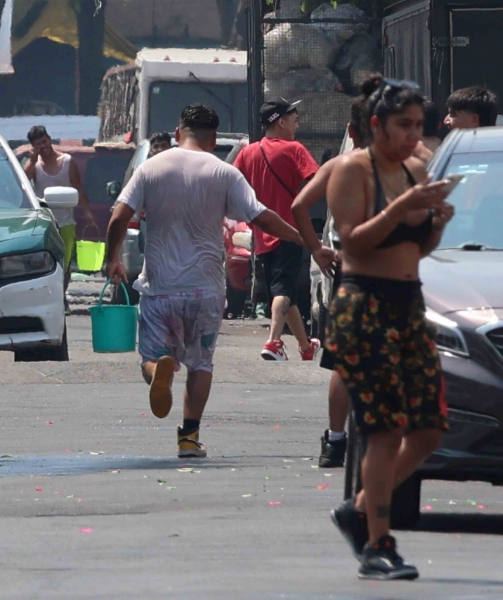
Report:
234,98,321,360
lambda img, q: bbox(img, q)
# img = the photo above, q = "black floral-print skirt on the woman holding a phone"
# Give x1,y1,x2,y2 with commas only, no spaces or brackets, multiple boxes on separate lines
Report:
325,275,447,435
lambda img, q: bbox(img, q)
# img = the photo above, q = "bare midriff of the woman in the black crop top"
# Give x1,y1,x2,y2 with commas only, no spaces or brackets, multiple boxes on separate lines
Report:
342,242,421,281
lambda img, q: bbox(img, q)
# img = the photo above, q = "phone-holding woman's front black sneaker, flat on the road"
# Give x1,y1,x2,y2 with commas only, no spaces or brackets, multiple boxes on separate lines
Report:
358,535,419,580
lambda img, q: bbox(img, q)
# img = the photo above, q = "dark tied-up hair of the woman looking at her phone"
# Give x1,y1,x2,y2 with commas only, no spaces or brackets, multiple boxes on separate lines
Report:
366,75,426,135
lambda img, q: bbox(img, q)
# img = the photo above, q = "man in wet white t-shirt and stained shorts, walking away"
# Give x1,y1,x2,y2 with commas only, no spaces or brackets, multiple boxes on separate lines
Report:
107,104,302,457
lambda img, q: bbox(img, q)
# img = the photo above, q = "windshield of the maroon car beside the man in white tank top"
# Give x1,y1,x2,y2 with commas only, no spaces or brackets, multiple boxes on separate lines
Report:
84,153,130,205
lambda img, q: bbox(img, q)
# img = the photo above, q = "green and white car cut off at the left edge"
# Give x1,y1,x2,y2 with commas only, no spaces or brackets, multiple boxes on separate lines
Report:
0,137,78,361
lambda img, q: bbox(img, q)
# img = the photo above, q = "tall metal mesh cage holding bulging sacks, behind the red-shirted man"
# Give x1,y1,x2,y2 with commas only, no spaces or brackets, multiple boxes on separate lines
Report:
248,1,381,161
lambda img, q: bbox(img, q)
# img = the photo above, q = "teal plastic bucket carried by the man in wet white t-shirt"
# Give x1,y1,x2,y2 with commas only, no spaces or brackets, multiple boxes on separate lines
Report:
89,279,138,352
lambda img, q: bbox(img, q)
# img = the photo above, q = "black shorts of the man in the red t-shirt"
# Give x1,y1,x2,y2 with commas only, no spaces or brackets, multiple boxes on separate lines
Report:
258,241,302,306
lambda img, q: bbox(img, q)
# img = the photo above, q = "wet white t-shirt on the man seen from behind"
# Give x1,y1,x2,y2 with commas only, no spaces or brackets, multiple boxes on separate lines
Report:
119,148,266,296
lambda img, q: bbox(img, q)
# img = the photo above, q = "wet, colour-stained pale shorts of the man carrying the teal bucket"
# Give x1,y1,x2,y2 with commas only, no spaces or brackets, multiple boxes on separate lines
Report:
138,291,225,373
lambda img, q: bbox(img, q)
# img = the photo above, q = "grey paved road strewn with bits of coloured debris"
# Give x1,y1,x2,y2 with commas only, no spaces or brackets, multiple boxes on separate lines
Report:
0,317,503,600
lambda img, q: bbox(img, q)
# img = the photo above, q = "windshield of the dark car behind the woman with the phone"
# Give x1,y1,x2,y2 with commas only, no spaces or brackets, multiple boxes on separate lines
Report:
440,152,503,250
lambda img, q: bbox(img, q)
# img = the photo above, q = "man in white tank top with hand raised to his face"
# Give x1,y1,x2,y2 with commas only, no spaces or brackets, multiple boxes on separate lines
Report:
24,125,94,304
